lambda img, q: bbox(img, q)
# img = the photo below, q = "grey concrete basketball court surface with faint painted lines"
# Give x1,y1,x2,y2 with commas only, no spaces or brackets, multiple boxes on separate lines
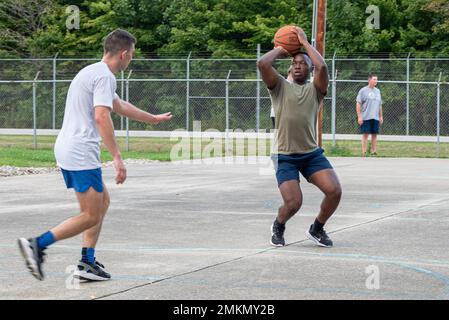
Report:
0,158,449,300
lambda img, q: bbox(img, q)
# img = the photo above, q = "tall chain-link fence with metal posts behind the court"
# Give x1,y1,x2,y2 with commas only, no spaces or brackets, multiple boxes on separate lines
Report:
0,55,449,158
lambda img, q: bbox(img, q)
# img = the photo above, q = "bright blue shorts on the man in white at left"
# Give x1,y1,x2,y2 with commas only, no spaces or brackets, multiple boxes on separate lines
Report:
61,168,103,193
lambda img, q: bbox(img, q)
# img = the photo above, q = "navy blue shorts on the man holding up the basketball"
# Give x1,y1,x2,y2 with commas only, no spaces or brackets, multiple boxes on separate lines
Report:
272,148,333,186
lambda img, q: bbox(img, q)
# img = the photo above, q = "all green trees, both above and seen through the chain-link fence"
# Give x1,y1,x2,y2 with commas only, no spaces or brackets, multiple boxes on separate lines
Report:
0,0,449,135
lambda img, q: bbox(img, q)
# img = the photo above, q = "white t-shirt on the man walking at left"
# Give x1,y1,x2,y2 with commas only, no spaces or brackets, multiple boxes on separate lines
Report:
55,61,118,171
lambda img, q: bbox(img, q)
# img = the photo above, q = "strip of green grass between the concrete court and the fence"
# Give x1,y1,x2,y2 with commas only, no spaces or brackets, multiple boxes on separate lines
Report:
0,136,449,167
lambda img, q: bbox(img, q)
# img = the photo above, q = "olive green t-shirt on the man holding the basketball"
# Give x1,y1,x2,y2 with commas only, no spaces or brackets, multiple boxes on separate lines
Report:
268,75,324,154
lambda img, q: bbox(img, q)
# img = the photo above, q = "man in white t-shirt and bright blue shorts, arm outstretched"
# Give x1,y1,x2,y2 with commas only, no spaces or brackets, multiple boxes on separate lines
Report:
18,29,172,280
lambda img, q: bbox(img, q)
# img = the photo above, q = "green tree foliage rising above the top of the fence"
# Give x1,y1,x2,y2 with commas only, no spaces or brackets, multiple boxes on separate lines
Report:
0,0,449,57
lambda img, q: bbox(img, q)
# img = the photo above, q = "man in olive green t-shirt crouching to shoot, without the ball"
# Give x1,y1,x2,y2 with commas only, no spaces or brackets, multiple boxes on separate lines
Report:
257,27,341,247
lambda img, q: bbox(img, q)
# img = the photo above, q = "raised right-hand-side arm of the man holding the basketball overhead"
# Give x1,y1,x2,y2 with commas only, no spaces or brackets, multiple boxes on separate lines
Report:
294,27,329,95
